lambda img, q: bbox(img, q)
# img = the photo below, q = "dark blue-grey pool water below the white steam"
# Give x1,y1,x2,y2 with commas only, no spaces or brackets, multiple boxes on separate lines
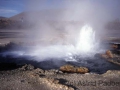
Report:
0,50,120,74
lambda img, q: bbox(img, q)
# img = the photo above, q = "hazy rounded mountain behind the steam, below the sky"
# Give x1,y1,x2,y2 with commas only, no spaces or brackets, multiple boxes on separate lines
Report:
9,9,83,29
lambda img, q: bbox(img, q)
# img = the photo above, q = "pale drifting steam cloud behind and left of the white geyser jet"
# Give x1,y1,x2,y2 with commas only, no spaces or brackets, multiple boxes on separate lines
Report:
1,0,120,60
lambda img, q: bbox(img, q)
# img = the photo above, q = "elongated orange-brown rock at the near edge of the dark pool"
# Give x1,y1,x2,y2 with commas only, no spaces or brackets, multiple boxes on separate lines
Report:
60,65,89,73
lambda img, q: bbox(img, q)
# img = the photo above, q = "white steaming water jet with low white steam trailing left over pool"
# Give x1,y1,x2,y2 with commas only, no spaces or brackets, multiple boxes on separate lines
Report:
2,25,99,61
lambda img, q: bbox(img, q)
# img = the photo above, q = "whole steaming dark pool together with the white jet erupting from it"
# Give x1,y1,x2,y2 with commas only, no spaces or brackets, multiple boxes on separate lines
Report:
0,25,119,73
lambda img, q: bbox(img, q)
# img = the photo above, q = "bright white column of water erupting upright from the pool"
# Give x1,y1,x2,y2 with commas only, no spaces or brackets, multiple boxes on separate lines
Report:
76,25,98,53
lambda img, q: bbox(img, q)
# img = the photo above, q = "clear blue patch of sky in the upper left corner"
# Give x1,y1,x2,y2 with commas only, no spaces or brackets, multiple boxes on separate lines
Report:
0,0,25,17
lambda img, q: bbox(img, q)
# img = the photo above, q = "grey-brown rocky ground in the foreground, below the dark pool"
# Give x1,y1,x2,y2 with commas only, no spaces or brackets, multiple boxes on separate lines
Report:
0,65,120,90
